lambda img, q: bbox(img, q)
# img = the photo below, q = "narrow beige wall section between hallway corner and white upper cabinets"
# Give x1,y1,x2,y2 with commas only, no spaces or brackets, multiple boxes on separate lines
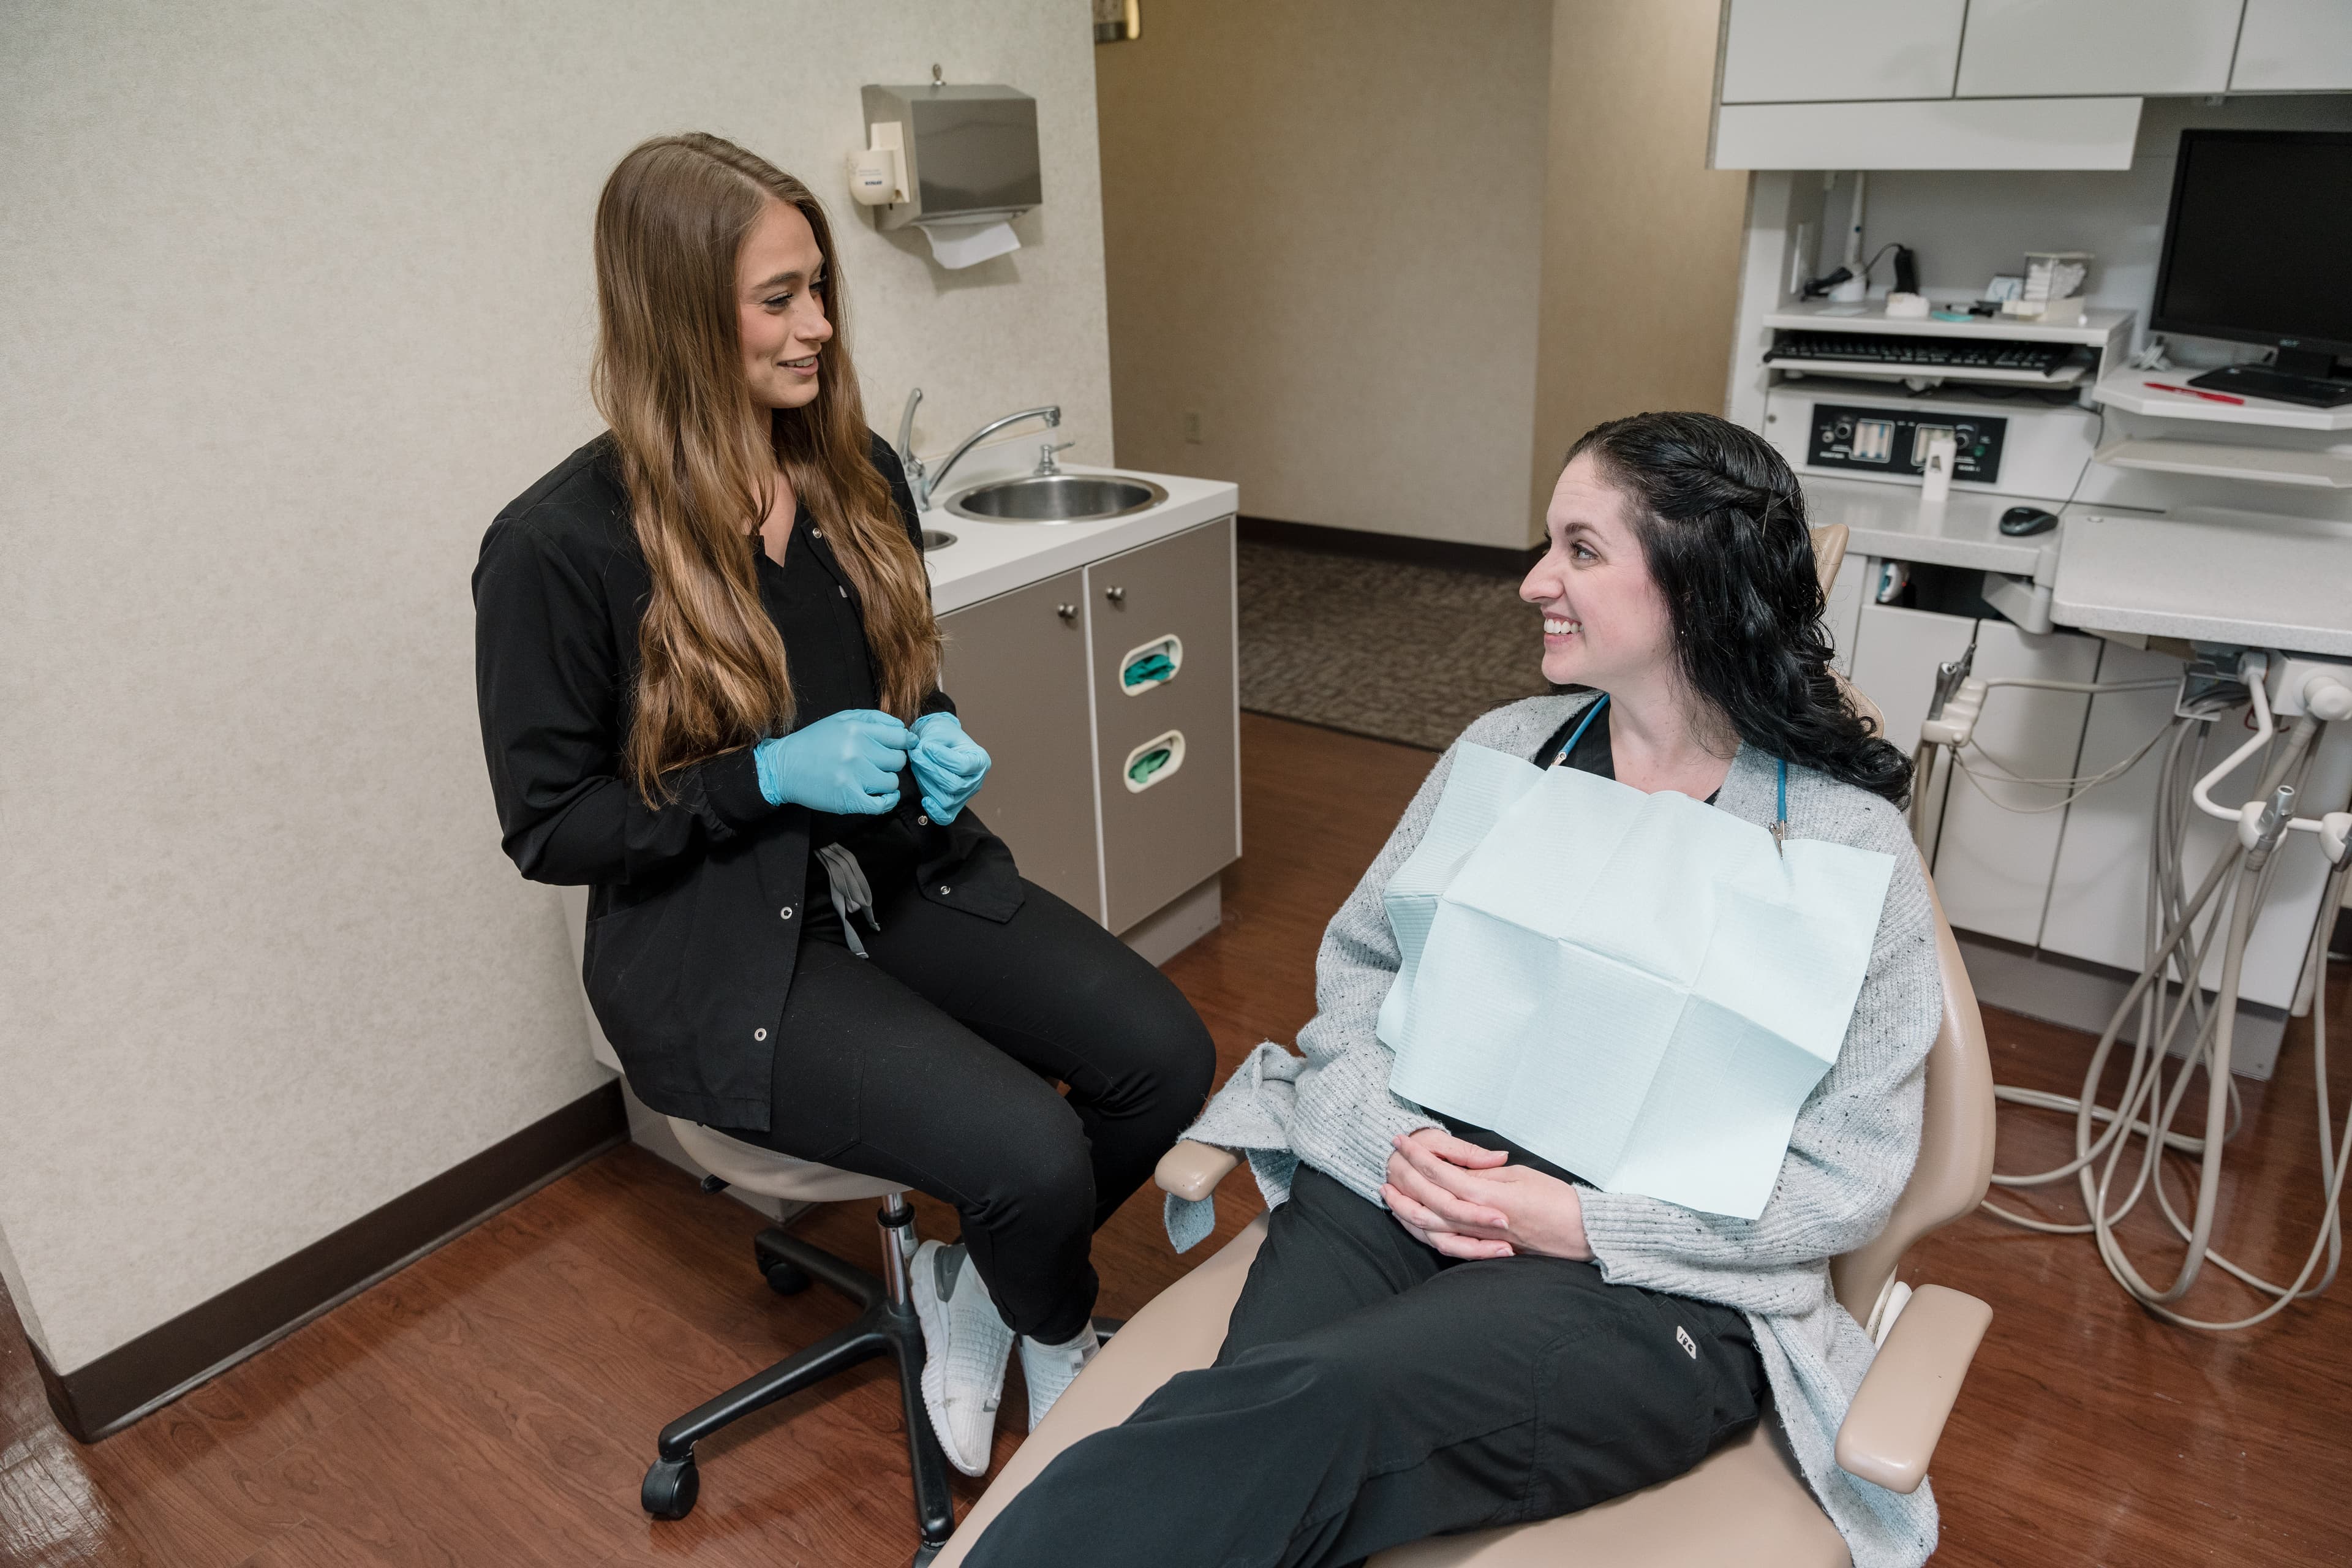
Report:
1531,0,1747,526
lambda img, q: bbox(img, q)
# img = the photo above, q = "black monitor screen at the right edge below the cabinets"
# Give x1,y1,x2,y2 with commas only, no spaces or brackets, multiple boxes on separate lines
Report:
2150,132,2352,353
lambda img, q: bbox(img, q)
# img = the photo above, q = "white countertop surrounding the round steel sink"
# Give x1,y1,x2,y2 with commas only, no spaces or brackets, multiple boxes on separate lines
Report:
922,454,1242,614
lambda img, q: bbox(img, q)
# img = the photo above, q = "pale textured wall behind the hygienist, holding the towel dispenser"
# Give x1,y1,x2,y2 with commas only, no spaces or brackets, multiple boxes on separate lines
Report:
0,0,1110,1371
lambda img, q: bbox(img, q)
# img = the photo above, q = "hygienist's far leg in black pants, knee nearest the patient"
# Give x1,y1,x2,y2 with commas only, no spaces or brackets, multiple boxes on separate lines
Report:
865,884,1216,1232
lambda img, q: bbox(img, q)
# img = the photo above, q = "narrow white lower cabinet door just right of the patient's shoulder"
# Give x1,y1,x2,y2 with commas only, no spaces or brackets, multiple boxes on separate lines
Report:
1936,620,2100,945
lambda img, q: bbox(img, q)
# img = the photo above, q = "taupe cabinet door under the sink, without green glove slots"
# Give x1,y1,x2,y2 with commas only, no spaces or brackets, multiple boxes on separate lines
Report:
938,571,1103,919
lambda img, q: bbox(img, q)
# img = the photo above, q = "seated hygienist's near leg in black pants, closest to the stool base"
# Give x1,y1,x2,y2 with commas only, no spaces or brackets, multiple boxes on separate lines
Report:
722,940,1096,1343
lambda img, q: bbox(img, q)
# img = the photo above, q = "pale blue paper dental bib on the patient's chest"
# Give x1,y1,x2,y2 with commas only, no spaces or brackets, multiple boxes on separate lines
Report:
1378,743,1893,1220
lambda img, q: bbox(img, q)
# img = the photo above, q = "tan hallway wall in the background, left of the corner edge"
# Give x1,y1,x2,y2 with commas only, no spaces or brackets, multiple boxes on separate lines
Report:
1096,0,1552,545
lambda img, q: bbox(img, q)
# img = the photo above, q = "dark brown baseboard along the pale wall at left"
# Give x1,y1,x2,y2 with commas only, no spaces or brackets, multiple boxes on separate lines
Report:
33,1079,628,1444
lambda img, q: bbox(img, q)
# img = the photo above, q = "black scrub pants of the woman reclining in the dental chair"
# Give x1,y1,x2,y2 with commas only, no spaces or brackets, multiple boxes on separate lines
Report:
967,1166,1764,1568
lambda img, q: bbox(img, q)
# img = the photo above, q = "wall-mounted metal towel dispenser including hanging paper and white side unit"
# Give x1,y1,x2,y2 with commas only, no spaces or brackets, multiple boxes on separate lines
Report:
851,82,1044,268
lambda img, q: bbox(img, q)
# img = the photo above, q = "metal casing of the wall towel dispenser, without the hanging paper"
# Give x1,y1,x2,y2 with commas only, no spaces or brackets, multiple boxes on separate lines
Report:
863,82,1044,228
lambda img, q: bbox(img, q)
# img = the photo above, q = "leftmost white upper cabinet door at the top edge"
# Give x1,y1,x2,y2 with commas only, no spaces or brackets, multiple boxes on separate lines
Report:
1722,0,1966,104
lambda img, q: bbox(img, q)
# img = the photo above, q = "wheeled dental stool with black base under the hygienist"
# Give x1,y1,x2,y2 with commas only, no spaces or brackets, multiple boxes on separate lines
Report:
639,1117,955,1568
